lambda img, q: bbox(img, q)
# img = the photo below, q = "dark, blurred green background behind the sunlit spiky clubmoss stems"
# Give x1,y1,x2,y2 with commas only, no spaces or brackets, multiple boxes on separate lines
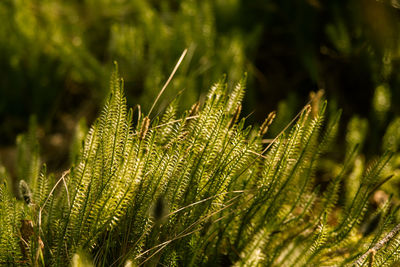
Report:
0,0,400,176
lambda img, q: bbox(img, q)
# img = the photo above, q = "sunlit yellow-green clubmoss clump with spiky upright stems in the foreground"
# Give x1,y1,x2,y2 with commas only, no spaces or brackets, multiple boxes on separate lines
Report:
0,63,400,266
